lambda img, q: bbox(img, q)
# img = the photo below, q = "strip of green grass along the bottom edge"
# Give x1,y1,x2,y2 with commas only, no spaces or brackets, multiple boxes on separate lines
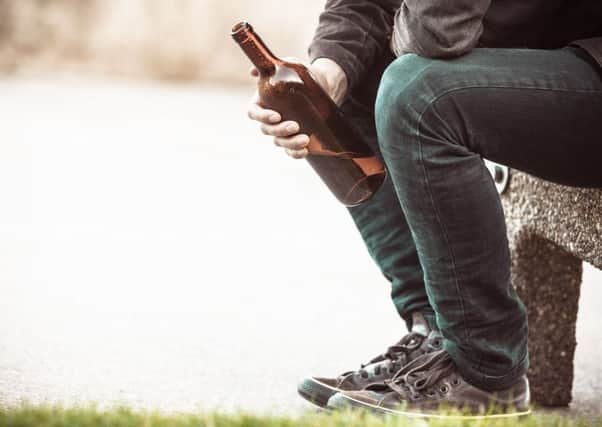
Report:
0,405,602,427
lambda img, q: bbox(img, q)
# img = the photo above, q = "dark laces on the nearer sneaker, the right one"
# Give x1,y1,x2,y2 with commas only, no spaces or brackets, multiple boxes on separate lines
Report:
385,350,456,397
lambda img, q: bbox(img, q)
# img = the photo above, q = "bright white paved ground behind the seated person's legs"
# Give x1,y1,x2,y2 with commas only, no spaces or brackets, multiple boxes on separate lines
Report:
0,79,602,413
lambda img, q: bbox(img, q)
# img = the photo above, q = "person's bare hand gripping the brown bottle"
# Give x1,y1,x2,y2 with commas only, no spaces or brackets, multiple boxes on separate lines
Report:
248,58,347,159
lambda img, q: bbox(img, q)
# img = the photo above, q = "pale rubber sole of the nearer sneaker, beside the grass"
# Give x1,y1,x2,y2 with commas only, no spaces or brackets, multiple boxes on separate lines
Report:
326,393,531,421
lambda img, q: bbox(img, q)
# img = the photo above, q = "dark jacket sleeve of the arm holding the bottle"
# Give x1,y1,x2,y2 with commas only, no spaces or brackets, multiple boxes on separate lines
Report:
309,0,400,93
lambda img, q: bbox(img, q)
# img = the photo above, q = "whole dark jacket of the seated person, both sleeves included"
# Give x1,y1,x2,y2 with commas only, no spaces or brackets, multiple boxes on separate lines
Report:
309,0,602,89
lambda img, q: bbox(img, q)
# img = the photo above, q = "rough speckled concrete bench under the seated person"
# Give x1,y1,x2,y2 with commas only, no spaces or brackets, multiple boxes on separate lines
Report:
498,171,602,405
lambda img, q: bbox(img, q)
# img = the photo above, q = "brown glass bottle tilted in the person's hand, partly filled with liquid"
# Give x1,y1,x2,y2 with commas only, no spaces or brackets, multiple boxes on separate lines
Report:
232,22,386,206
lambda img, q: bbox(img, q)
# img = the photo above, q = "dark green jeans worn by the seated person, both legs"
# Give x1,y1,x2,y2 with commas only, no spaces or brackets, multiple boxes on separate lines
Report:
350,48,602,389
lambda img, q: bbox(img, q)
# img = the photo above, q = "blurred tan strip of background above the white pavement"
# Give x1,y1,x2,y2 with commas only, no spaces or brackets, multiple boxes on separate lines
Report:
0,0,323,83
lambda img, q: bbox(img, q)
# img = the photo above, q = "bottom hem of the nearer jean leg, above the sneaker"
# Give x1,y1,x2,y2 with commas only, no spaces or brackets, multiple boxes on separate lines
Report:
443,339,529,391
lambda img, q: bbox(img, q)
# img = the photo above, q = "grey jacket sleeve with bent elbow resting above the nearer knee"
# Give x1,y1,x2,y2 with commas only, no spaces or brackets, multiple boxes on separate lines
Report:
391,0,491,58
